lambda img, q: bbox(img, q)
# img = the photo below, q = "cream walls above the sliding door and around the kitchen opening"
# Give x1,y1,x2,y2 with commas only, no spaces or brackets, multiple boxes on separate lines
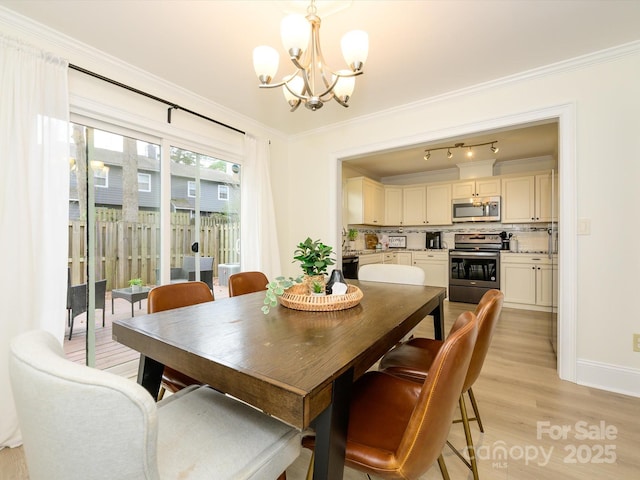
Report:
5,7,640,396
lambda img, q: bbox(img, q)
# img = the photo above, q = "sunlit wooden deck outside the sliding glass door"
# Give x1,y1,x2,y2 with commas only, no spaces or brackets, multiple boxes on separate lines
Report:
64,279,229,377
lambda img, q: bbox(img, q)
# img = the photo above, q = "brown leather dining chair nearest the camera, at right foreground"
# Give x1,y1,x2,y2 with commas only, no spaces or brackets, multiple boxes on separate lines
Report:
302,312,477,480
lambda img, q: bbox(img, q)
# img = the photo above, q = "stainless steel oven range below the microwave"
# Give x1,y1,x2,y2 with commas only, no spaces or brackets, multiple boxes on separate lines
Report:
449,233,502,303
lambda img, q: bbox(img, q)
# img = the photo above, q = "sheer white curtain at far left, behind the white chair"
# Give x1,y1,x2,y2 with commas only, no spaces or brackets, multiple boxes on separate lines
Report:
0,33,69,448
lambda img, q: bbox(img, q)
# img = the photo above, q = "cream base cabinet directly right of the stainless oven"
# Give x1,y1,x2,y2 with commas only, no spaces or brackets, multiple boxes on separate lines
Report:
500,253,558,309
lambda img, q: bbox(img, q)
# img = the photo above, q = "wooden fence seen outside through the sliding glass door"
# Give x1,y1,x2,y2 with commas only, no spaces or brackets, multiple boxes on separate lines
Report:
69,214,240,290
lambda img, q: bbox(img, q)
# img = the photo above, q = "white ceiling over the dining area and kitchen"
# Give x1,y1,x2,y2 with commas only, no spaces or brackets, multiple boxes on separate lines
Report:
0,0,640,177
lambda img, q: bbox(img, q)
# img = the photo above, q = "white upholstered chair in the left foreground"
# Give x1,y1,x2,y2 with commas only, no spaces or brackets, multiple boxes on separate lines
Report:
9,330,301,480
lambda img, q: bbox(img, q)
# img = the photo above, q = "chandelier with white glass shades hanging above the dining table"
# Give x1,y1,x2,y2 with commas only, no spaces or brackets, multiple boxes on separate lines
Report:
253,0,369,112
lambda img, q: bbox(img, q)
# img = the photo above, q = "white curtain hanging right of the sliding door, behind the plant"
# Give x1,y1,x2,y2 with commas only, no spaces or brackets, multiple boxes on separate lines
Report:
240,134,282,280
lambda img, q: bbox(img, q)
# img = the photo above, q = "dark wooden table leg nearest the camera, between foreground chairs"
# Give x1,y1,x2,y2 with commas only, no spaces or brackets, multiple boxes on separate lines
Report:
313,368,353,480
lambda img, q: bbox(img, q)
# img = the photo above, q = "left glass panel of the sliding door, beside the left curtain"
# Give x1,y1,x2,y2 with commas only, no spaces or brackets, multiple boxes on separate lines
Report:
65,124,161,369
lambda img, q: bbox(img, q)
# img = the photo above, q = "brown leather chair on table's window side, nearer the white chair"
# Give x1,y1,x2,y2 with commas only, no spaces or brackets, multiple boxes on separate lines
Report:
147,282,214,400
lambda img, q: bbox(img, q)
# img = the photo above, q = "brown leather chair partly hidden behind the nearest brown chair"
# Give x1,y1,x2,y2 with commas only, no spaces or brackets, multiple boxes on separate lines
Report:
380,289,504,480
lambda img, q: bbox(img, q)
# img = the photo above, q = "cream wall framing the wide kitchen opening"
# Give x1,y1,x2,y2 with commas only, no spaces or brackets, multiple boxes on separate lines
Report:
275,43,640,396
